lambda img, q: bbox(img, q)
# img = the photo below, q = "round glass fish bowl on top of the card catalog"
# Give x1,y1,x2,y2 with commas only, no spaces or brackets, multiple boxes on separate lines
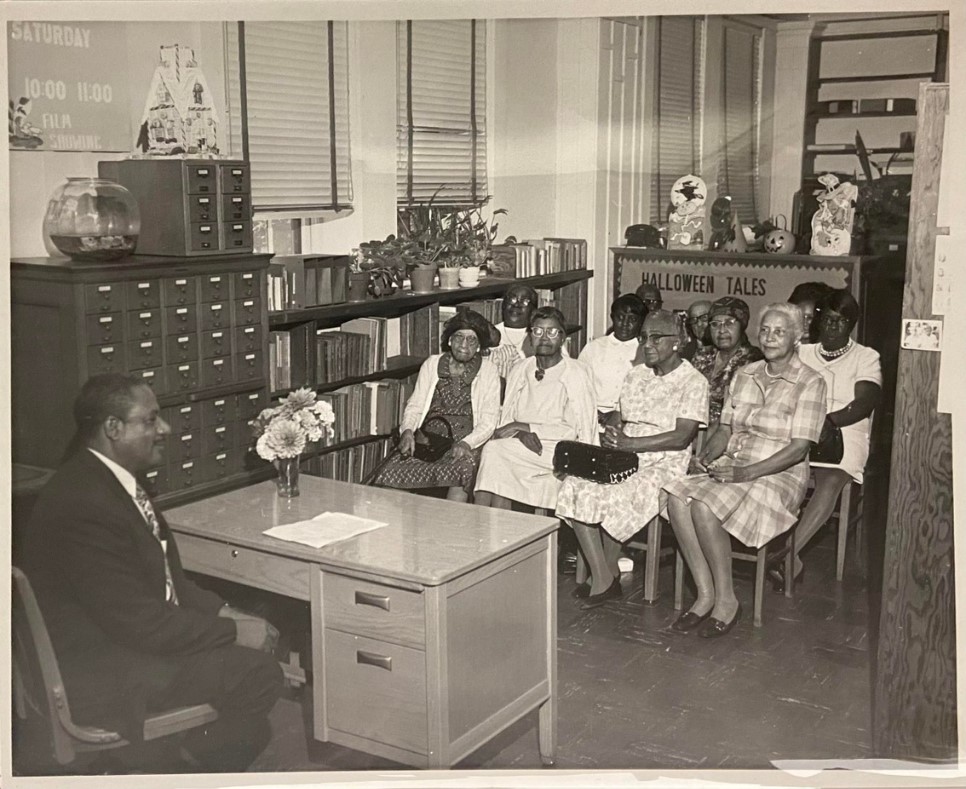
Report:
44,178,141,261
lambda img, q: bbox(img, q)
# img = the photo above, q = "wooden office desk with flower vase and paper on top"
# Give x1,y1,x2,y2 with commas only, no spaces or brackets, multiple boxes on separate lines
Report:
165,476,557,768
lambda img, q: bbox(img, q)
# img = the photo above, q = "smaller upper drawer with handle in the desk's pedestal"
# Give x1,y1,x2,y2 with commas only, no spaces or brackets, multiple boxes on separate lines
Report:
322,572,426,648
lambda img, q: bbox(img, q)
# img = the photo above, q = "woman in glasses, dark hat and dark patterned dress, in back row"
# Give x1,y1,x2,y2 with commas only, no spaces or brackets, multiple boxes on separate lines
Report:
691,296,762,425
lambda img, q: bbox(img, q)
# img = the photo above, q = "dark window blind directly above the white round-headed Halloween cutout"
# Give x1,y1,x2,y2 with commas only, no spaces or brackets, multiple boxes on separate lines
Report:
651,17,704,223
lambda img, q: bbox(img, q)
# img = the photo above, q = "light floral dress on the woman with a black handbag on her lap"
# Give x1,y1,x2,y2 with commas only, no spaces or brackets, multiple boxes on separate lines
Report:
557,361,708,542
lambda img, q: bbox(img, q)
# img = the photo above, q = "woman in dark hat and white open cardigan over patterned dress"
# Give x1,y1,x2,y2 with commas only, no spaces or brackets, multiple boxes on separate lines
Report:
373,310,500,501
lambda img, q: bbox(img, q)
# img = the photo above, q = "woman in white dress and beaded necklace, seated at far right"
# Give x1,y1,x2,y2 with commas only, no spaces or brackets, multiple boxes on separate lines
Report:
769,290,882,592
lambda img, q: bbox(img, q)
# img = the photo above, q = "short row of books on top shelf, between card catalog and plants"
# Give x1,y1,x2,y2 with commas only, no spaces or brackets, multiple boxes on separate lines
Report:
268,255,349,312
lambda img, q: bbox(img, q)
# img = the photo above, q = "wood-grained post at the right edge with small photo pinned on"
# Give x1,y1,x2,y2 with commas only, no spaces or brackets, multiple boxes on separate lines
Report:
873,83,957,760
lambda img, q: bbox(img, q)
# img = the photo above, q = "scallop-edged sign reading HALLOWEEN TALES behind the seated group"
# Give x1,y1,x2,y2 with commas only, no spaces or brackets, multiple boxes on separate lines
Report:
613,248,854,336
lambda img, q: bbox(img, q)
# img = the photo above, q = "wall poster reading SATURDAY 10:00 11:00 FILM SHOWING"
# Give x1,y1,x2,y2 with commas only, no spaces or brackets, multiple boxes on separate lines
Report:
7,21,133,152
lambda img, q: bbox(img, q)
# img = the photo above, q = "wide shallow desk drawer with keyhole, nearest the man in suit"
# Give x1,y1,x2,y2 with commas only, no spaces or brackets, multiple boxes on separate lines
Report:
177,534,310,600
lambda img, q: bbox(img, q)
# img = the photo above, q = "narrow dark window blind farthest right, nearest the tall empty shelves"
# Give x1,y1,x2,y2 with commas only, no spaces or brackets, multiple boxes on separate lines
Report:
718,22,762,224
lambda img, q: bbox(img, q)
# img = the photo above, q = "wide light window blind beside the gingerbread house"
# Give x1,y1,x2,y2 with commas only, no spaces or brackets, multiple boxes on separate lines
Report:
225,22,352,214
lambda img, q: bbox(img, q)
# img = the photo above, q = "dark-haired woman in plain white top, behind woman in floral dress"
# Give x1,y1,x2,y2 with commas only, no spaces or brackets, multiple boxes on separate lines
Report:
580,293,647,420
